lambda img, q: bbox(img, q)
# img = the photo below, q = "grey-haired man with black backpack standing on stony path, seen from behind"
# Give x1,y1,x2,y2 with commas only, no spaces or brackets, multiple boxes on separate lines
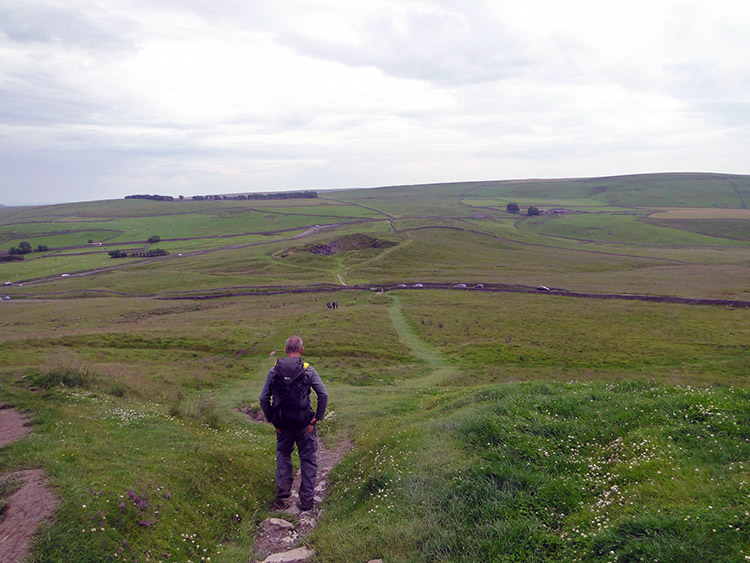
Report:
260,335,328,510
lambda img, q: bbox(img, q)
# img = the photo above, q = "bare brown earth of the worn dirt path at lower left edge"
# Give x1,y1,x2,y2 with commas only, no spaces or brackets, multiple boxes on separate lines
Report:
0,407,59,563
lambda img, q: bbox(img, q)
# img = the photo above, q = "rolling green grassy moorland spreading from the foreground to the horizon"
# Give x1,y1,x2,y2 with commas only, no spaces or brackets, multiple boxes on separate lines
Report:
0,174,750,562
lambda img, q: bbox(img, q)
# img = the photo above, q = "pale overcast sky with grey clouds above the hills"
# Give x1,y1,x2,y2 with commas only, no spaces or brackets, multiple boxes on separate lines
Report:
0,0,750,205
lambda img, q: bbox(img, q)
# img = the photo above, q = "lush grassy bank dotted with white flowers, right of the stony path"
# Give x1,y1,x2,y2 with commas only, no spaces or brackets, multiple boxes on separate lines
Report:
315,383,750,562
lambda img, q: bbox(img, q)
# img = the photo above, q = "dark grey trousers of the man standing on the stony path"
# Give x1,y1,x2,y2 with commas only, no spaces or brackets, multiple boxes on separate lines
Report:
276,426,318,504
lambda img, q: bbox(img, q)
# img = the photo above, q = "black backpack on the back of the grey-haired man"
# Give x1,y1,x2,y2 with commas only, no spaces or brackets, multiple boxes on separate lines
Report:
271,361,313,430
